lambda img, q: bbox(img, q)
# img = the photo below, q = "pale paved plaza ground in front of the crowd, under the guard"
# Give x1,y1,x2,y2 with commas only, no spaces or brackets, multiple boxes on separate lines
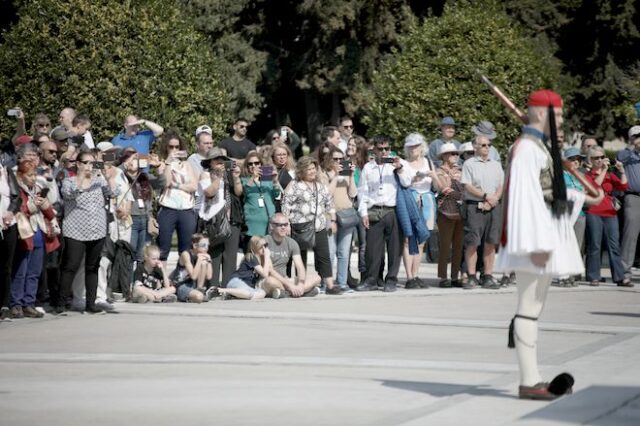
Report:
0,265,640,426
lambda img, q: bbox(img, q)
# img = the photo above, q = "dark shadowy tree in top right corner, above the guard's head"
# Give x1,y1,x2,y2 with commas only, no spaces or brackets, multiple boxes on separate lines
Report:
504,0,640,138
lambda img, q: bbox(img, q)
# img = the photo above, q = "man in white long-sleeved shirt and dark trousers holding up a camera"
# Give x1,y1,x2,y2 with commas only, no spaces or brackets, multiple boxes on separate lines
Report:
356,136,403,292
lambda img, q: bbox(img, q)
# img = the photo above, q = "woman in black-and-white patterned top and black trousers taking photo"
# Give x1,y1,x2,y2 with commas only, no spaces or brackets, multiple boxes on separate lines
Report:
56,151,116,313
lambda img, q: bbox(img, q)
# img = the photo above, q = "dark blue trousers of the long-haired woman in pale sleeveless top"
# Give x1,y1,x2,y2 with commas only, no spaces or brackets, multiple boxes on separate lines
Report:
158,207,196,260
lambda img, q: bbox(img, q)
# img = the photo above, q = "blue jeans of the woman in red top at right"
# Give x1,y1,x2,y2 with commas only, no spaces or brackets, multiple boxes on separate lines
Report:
587,214,624,283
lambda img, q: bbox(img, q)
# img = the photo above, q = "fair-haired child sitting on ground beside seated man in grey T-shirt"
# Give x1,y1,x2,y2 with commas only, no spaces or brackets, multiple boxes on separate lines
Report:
218,235,271,300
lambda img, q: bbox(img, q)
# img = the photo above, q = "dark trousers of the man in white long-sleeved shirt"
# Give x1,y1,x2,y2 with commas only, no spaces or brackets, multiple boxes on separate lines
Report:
364,211,403,281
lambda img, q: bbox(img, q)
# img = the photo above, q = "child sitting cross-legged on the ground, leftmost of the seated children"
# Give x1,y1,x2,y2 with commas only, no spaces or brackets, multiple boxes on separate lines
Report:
133,244,177,303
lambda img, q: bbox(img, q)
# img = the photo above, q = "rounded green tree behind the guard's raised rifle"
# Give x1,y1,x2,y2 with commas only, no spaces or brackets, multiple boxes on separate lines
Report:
357,0,563,152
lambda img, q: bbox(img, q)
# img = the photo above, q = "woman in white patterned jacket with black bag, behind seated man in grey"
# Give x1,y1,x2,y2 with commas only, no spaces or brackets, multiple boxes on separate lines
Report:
282,157,342,295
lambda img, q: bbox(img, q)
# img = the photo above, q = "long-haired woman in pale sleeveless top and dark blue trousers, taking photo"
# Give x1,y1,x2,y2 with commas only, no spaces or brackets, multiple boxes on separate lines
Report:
158,132,198,262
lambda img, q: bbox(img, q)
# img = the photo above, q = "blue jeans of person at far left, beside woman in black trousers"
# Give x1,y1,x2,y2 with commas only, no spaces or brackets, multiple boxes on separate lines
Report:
10,247,44,307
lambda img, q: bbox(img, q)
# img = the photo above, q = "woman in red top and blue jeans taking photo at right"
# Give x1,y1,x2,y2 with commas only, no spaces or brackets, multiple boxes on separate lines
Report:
586,146,633,287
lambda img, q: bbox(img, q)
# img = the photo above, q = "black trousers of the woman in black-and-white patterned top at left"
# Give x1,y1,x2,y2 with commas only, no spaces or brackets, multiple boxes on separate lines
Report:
58,238,104,309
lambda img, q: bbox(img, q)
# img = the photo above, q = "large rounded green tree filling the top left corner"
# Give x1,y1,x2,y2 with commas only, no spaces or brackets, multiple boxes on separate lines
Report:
0,0,230,143
